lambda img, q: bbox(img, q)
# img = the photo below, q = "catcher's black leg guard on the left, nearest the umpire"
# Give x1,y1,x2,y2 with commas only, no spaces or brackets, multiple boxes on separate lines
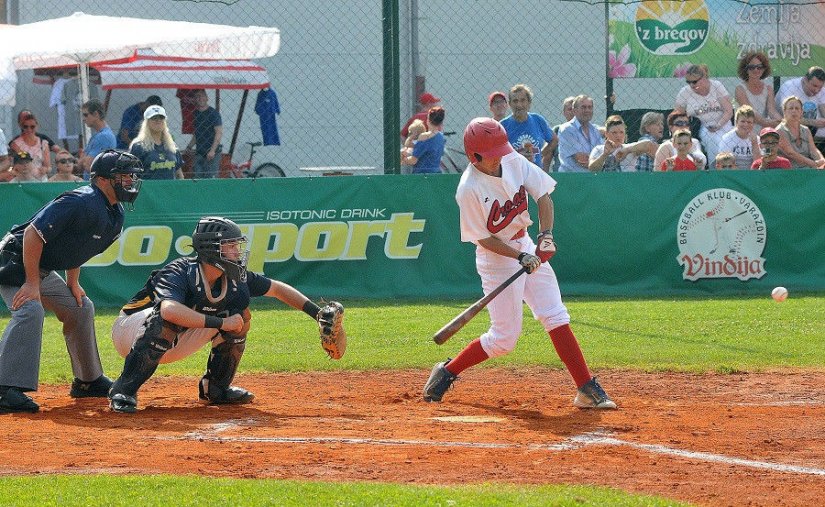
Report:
110,310,172,397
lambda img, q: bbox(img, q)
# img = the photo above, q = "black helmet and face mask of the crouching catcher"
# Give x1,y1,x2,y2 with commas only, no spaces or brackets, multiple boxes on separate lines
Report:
192,217,249,282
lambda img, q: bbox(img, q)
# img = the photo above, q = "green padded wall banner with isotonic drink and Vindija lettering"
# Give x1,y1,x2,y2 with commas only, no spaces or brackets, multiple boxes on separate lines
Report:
0,170,825,306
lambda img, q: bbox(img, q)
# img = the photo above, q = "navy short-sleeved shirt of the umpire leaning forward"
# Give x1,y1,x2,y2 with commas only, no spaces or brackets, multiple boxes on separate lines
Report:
6,185,123,271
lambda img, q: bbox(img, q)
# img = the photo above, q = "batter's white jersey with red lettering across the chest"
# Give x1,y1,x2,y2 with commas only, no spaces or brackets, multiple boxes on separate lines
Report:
455,152,556,244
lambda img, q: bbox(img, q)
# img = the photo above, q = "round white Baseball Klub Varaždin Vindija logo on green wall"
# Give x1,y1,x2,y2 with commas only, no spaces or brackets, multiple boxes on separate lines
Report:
676,188,767,281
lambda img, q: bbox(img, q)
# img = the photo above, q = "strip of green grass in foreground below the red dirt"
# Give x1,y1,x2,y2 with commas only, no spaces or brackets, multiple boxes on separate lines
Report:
0,476,687,507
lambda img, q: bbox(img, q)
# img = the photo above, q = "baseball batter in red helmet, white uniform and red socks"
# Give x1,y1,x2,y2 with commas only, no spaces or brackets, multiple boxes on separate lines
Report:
424,118,616,409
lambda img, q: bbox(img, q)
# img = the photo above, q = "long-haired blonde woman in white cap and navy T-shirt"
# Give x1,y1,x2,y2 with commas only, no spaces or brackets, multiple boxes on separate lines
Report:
129,105,183,180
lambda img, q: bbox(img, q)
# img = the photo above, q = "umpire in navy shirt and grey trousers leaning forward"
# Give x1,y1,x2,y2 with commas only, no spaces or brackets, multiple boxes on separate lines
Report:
0,150,143,414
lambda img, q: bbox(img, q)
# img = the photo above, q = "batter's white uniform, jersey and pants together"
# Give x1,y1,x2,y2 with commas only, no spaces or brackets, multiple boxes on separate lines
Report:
455,153,570,357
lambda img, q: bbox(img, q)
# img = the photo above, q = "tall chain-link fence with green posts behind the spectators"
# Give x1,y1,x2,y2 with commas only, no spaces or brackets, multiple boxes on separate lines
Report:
0,0,825,176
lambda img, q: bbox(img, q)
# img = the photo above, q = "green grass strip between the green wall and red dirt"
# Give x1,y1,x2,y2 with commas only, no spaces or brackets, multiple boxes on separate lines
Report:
0,295,825,383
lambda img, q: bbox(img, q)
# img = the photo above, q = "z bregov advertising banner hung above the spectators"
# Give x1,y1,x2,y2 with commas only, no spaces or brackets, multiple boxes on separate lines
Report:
608,0,825,78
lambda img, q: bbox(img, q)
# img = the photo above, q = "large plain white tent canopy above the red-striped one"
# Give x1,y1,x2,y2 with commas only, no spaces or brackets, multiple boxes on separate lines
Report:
0,12,281,122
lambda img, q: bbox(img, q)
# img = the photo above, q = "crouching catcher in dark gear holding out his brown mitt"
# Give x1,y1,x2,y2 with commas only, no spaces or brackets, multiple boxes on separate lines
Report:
109,217,346,413
